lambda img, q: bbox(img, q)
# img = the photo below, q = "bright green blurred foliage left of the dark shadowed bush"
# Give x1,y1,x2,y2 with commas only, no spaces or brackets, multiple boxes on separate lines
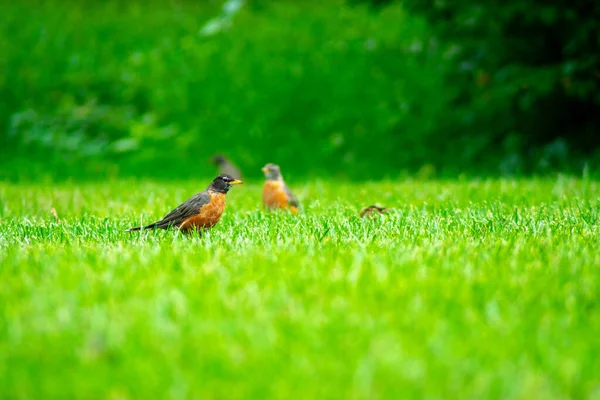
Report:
0,1,445,179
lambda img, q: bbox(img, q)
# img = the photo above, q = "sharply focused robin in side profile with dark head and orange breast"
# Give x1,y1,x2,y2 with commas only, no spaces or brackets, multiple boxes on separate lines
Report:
126,174,242,232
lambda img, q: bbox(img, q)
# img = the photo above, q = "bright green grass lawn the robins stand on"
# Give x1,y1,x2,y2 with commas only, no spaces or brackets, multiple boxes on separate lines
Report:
0,177,600,399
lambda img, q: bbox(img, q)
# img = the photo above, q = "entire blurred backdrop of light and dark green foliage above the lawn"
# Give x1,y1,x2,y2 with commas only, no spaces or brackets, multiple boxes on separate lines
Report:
0,0,600,181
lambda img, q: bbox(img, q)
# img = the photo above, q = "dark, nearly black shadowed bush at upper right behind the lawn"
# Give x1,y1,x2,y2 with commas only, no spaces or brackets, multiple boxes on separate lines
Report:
360,0,600,173
